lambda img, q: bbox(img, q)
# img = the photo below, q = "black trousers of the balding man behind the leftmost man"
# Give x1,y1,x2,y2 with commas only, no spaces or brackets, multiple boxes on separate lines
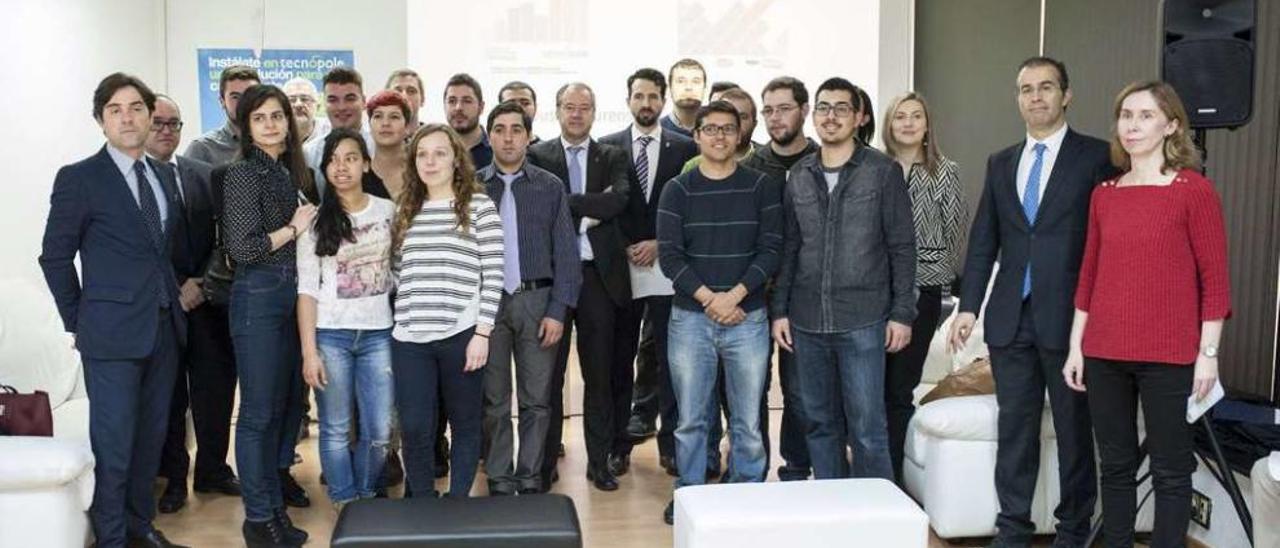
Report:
160,303,236,489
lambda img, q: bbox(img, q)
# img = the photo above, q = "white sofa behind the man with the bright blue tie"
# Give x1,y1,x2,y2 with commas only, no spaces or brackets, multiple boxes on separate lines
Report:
902,302,1155,538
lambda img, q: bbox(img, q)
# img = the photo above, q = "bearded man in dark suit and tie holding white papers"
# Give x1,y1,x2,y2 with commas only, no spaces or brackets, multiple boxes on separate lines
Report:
600,68,698,474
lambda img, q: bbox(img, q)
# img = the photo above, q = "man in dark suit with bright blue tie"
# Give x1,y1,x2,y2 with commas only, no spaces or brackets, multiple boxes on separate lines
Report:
950,58,1114,547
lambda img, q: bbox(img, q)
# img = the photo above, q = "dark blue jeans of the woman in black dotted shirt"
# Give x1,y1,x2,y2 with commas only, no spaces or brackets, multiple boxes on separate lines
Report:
228,265,302,521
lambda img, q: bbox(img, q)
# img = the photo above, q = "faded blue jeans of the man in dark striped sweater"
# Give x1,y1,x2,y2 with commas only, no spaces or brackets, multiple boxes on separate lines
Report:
667,306,769,488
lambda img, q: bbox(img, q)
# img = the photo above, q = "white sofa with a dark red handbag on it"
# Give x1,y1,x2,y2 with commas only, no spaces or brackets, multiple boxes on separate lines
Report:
0,279,93,548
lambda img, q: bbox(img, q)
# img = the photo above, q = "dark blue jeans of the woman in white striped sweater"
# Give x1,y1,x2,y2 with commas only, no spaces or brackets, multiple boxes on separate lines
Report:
392,328,484,498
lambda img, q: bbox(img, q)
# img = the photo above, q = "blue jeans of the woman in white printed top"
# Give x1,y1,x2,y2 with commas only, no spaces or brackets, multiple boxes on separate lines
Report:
315,329,393,502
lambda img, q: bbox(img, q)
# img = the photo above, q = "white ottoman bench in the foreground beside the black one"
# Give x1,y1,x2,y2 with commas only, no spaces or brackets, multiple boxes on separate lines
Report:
675,479,929,548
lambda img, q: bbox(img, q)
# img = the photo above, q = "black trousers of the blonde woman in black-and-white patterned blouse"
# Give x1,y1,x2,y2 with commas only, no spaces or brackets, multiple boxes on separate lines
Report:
884,286,942,484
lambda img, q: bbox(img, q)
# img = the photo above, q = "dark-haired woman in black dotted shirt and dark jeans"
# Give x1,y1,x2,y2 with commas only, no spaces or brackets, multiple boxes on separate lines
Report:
221,85,315,547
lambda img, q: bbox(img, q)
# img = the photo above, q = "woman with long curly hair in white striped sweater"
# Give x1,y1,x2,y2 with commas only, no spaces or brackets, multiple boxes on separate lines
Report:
392,124,503,498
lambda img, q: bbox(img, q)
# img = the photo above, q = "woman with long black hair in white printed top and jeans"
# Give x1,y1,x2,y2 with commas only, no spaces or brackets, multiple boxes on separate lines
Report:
297,128,396,511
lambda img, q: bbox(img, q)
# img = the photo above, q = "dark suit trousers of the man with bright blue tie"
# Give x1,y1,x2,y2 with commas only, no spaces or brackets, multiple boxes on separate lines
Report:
991,297,1097,545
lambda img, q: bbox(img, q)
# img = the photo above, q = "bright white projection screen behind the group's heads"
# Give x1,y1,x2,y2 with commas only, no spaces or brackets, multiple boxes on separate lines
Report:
407,0,911,141
